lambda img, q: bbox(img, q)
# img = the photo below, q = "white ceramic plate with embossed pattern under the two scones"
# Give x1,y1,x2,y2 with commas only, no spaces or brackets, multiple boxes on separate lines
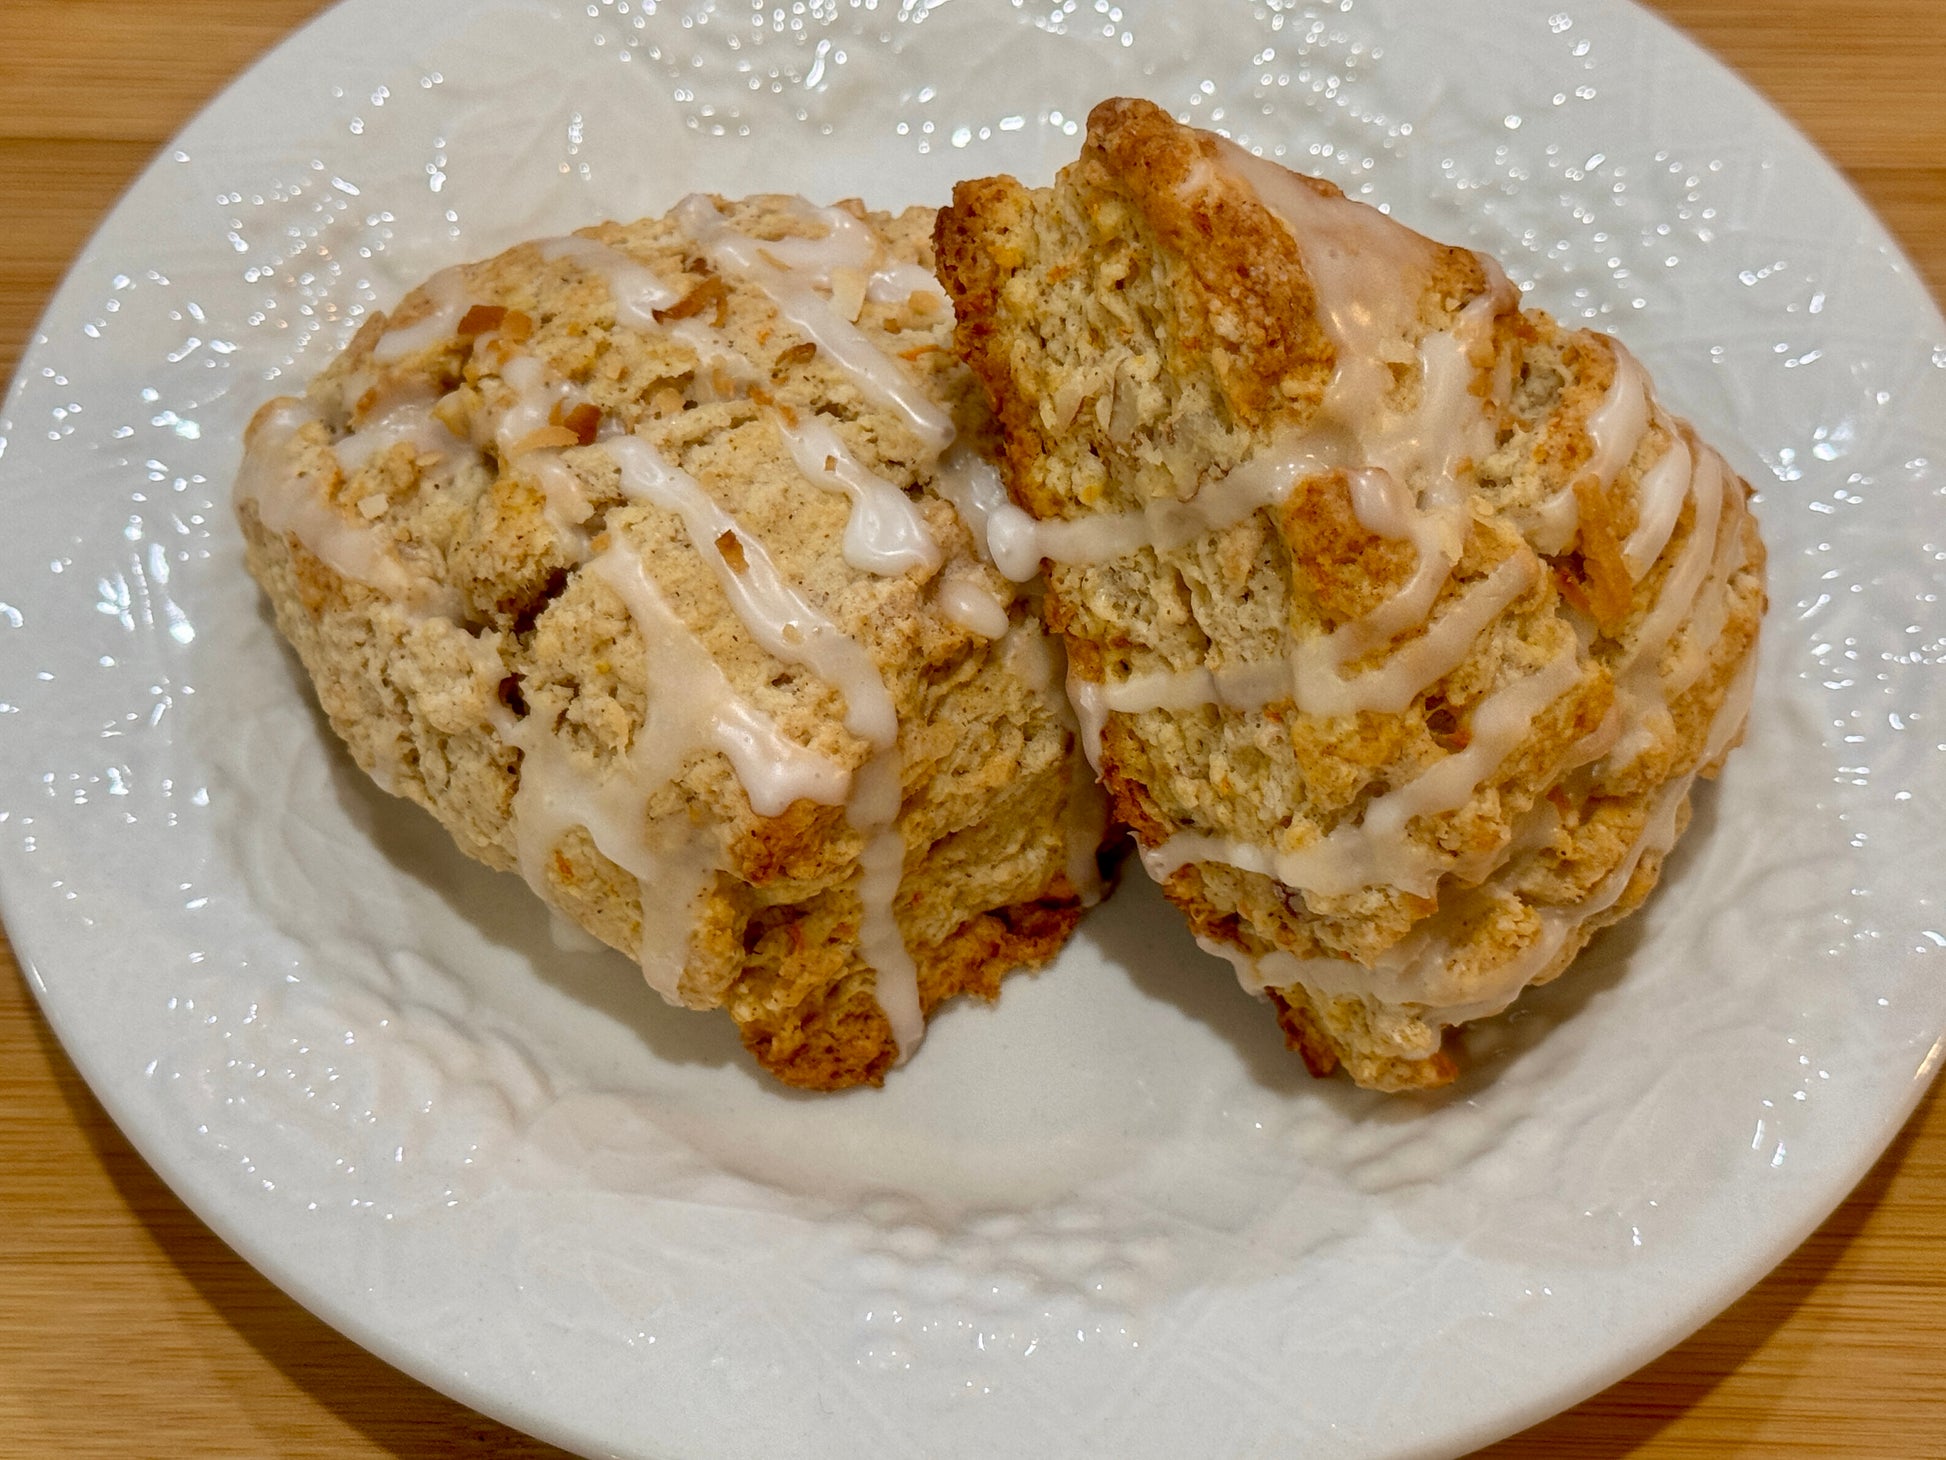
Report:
0,0,1946,1460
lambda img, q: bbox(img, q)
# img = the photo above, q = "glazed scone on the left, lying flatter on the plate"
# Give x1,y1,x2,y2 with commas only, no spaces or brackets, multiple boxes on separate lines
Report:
237,195,1101,1090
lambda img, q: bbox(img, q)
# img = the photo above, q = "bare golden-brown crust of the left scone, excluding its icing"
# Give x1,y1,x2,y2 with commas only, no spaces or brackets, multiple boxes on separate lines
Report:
239,199,1092,1088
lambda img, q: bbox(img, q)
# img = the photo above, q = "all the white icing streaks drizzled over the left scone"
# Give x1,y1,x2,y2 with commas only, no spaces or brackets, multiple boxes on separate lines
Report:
237,199,1066,1061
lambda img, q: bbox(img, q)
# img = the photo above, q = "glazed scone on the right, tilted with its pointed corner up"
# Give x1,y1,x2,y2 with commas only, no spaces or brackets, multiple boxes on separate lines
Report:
936,101,1765,1090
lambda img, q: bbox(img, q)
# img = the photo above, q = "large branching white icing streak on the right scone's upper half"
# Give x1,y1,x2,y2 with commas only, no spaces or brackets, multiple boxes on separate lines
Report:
989,144,1537,778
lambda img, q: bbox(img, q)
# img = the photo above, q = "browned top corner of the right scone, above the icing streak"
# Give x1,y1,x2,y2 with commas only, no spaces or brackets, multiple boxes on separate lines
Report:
934,101,1333,518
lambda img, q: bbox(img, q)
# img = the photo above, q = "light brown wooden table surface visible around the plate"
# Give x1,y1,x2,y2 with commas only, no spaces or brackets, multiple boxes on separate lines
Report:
0,0,1946,1460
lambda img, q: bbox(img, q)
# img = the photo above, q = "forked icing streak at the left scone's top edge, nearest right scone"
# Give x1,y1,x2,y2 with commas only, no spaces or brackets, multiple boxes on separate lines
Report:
675,193,954,452
